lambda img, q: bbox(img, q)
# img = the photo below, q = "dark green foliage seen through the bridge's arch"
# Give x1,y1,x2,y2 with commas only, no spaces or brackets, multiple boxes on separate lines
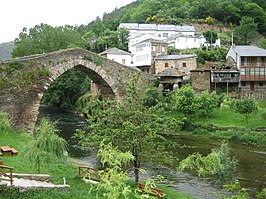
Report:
42,68,90,109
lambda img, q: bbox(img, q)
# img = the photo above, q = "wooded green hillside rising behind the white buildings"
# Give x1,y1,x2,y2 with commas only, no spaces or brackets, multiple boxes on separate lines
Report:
77,0,266,52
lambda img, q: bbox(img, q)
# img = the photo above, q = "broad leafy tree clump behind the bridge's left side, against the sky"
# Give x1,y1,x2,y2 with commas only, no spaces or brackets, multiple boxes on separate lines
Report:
12,24,84,57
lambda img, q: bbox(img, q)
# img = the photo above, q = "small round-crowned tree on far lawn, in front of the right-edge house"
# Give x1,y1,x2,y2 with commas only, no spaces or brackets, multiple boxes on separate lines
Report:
234,99,258,124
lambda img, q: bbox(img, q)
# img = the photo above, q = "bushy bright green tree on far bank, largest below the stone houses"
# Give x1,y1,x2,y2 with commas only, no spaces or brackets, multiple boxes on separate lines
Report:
172,85,198,117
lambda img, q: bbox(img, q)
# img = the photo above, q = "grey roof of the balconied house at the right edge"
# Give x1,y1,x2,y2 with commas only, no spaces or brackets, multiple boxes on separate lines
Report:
231,46,266,56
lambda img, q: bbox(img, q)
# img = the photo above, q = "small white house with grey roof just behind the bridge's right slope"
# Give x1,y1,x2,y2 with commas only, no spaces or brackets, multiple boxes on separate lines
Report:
99,48,134,66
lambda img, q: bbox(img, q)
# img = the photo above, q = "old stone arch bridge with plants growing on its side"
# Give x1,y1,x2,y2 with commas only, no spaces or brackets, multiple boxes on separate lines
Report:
0,48,153,131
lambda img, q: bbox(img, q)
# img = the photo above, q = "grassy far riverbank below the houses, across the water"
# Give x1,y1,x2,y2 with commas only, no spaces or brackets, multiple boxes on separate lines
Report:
166,100,266,146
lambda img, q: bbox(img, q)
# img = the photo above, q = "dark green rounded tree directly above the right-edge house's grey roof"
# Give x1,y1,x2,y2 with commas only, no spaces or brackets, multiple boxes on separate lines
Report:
234,16,258,45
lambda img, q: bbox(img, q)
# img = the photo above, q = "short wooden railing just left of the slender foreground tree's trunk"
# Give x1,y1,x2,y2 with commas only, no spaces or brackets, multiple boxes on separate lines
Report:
78,166,101,182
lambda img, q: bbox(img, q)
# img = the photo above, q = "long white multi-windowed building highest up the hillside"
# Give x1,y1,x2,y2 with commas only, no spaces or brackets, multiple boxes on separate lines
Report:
119,23,195,39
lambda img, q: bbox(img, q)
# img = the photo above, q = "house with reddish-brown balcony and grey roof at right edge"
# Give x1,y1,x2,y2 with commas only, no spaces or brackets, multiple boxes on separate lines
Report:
226,45,266,99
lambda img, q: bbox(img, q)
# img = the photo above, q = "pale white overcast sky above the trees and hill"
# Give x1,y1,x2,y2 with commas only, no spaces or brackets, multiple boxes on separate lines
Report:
0,0,134,43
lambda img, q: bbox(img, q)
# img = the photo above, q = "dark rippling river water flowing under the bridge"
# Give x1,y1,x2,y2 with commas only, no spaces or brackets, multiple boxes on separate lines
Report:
39,106,266,199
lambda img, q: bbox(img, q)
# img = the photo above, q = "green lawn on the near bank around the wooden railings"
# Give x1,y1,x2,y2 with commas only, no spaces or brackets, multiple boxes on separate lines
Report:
0,112,195,199
